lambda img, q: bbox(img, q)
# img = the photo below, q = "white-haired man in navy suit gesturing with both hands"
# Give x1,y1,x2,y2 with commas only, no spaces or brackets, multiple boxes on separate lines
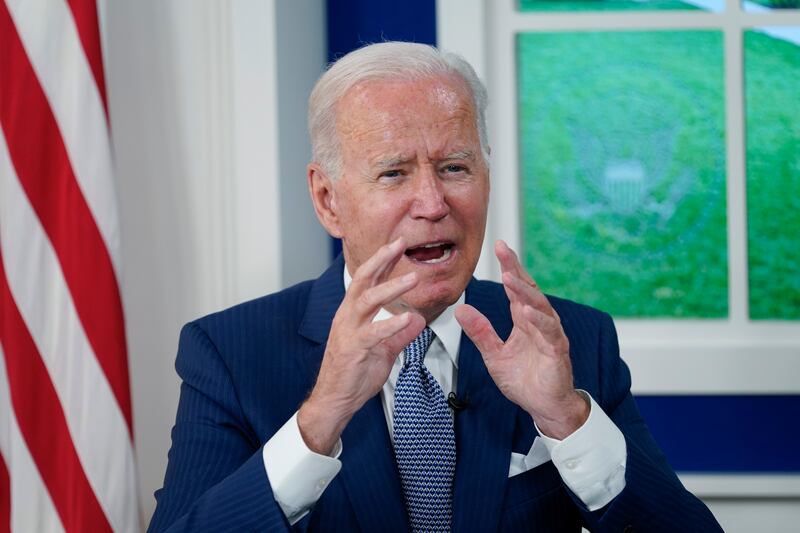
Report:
150,43,719,532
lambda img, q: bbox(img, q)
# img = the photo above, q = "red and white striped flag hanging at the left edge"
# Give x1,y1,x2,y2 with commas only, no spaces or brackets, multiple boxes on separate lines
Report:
0,0,140,533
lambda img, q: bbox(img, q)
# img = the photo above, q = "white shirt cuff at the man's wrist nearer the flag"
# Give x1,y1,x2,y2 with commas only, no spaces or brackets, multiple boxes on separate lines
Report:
263,413,342,525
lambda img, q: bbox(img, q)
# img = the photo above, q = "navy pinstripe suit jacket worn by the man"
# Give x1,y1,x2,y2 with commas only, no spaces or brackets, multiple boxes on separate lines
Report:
150,257,720,532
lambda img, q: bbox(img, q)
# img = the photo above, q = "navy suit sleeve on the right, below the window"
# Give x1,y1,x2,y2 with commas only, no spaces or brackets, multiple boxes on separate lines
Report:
579,314,722,533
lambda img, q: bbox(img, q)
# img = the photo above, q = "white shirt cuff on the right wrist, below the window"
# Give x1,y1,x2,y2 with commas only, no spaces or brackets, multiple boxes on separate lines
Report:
534,390,628,511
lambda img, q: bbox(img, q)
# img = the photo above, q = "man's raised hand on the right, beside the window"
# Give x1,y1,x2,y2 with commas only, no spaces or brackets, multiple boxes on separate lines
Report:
456,241,589,439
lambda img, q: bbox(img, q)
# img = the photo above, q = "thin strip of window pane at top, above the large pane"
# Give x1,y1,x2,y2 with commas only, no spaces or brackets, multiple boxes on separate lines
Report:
519,0,720,12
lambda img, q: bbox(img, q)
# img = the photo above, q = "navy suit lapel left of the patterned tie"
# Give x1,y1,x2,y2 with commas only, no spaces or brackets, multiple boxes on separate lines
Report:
298,255,409,532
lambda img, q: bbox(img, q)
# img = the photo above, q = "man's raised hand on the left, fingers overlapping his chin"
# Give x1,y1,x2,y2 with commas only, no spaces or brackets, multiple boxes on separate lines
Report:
297,239,425,455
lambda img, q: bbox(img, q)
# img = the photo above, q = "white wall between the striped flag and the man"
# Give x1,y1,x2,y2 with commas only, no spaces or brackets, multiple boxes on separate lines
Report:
101,0,329,523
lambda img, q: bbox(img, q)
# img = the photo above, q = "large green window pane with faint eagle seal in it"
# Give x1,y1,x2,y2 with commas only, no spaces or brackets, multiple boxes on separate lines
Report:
517,31,728,317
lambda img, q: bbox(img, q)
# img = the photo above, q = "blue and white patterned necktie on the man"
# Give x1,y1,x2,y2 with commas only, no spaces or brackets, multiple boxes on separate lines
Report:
394,328,456,532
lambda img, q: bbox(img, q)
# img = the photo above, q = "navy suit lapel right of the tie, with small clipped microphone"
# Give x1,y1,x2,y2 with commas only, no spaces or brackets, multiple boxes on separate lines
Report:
453,279,517,531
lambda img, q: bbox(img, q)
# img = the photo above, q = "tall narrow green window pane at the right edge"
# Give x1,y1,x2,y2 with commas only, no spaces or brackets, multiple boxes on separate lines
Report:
744,28,800,320
